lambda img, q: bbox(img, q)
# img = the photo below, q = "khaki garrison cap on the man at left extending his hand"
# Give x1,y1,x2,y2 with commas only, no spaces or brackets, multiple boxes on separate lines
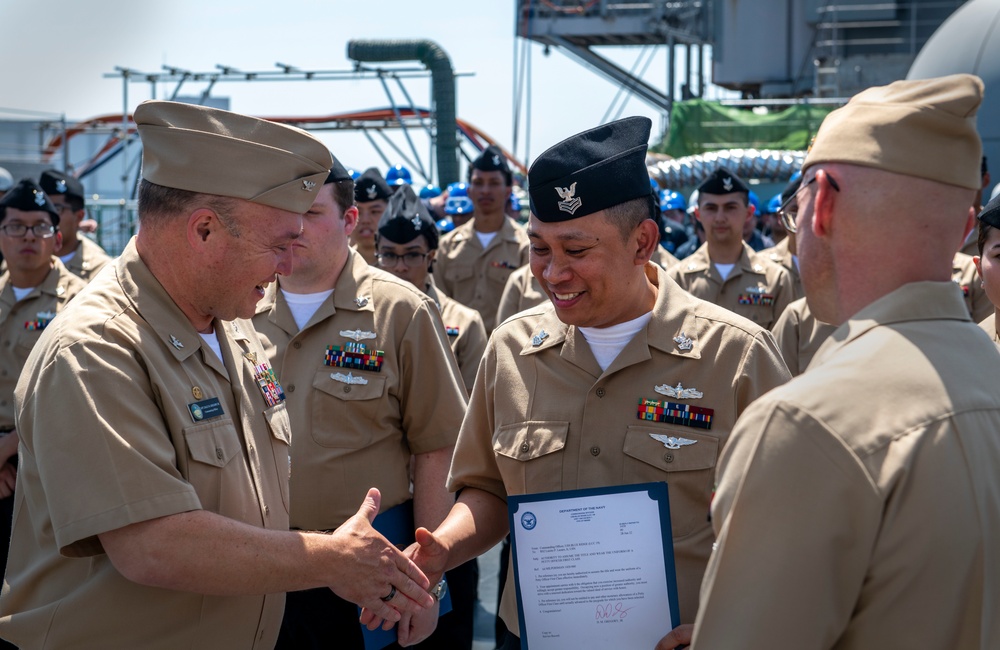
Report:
134,101,333,214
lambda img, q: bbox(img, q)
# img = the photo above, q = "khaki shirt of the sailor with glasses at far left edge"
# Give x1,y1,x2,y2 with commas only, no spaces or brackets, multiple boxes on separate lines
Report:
0,257,86,431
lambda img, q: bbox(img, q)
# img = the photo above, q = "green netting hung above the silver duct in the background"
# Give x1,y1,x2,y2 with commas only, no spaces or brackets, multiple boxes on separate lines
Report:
653,99,836,158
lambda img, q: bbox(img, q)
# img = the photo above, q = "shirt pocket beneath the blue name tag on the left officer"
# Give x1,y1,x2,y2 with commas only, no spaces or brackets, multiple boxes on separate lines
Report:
184,418,245,516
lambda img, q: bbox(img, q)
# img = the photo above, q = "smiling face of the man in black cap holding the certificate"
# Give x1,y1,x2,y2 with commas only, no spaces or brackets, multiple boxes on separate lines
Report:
528,210,659,327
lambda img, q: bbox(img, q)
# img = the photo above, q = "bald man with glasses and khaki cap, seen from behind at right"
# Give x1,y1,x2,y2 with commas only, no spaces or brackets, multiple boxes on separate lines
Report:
661,75,1000,650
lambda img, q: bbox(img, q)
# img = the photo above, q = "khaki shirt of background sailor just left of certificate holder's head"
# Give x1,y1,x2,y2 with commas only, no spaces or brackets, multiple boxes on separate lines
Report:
434,218,528,334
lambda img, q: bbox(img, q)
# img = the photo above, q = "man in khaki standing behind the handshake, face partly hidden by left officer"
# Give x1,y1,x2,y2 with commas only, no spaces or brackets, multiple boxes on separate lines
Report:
253,160,466,650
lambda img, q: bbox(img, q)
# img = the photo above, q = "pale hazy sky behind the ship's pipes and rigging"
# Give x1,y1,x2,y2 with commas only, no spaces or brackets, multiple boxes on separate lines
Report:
0,0,728,182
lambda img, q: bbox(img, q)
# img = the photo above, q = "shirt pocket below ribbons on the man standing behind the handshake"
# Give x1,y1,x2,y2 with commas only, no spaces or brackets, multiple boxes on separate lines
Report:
309,368,386,449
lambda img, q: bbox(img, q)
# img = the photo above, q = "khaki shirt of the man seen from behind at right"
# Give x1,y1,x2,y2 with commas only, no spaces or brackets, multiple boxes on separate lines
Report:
692,282,1000,650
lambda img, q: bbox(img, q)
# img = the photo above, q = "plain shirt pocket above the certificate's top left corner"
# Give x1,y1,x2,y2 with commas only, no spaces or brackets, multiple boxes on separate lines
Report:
493,421,569,494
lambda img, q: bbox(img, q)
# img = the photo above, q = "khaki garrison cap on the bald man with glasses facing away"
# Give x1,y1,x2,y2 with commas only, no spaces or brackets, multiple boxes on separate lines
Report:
802,74,983,190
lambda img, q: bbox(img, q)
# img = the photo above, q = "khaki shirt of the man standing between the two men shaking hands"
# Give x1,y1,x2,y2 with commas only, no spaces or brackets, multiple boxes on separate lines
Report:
254,251,466,530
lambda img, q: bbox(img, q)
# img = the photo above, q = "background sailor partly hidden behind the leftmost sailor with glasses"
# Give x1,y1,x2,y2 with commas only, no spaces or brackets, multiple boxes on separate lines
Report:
38,169,111,282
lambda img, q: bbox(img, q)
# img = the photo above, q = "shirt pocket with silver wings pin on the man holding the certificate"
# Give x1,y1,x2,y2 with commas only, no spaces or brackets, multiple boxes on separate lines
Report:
622,425,719,538
